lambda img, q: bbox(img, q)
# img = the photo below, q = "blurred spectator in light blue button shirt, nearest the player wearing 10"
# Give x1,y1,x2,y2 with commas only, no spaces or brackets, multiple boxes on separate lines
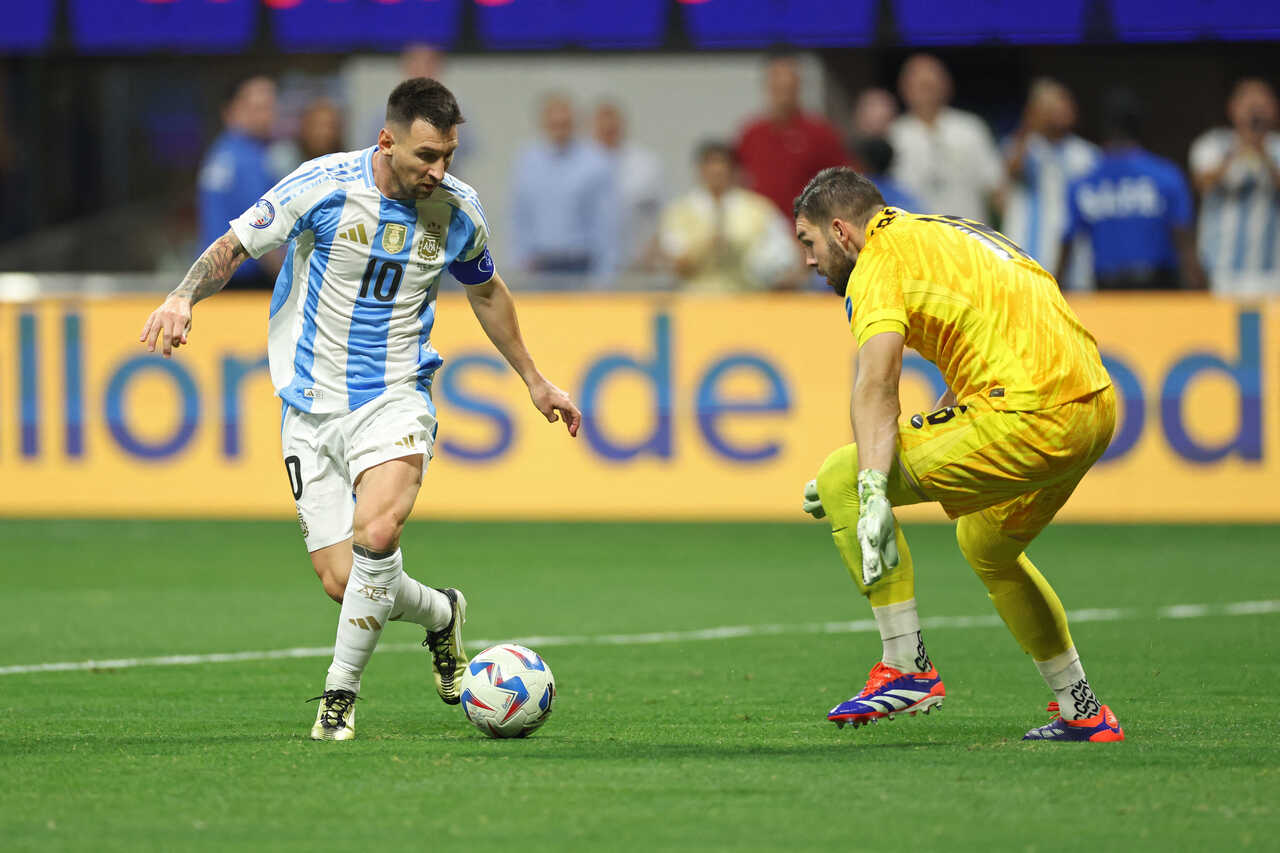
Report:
507,95,621,287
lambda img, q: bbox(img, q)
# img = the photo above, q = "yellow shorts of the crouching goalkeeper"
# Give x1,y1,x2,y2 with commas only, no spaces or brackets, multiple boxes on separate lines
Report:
818,387,1116,542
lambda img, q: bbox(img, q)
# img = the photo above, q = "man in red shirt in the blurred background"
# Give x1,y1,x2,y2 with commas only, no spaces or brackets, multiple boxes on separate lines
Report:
736,55,849,218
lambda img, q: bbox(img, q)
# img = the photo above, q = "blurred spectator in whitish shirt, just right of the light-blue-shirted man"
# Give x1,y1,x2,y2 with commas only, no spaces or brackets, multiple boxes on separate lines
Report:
591,101,663,269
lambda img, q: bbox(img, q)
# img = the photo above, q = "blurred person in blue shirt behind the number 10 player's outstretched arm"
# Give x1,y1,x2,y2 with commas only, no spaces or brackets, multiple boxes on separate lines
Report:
197,77,280,289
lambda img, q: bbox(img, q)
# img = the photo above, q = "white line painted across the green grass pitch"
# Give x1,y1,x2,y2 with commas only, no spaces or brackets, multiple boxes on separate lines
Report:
0,599,1280,675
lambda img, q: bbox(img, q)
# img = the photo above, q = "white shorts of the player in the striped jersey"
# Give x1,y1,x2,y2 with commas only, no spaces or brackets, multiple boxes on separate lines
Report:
280,386,436,551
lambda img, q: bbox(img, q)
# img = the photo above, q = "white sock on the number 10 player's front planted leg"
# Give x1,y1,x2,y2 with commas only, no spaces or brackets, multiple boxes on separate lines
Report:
324,548,403,693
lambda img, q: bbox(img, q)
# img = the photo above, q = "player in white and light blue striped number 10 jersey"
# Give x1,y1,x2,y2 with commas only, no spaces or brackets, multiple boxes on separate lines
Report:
141,77,581,740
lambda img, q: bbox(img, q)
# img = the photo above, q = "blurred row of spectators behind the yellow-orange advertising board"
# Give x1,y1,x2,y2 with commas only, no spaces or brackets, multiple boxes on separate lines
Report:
0,45,1280,295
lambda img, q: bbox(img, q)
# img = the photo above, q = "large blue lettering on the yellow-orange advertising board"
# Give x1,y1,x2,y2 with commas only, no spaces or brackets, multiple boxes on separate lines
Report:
17,310,1263,464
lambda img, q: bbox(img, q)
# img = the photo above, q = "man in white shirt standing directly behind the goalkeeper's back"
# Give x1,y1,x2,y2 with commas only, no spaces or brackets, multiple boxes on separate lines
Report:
890,54,1004,220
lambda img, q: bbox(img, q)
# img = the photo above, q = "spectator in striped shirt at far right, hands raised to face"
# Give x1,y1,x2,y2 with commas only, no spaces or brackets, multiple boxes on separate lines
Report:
1190,78,1280,296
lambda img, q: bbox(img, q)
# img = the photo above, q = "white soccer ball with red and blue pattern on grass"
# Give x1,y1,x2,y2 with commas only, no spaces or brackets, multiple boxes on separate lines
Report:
461,643,556,738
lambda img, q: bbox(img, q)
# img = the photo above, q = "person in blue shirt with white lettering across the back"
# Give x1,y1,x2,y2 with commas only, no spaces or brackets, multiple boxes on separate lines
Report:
1057,91,1204,291
